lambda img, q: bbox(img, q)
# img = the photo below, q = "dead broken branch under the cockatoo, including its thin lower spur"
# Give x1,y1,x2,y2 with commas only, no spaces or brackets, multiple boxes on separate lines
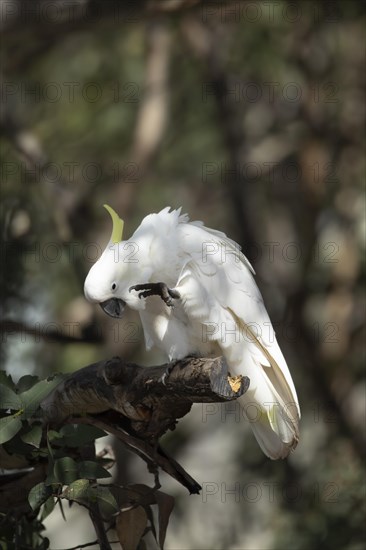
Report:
42,357,249,493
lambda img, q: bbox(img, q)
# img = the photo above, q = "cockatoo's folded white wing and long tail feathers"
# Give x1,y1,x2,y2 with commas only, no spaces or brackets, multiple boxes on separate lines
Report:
175,223,300,458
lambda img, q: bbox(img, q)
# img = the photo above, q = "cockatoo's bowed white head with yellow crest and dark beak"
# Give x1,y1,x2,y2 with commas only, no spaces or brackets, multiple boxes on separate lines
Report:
84,205,148,318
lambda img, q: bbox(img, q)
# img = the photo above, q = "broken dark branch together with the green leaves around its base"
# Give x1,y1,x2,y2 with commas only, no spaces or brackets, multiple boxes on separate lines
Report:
0,357,249,549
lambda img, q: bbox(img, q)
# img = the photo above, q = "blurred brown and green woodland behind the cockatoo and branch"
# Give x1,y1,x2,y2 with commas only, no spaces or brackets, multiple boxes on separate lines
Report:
0,0,365,550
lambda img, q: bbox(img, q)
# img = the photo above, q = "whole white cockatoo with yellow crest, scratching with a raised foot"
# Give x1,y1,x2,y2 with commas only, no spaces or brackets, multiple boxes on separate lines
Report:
84,205,300,459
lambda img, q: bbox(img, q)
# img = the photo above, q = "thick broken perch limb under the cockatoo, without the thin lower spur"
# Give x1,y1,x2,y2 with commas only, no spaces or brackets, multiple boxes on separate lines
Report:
42,357,249,432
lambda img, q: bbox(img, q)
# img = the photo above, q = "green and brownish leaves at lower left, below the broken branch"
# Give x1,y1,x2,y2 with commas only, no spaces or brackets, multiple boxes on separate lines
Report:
0,371,174,550
